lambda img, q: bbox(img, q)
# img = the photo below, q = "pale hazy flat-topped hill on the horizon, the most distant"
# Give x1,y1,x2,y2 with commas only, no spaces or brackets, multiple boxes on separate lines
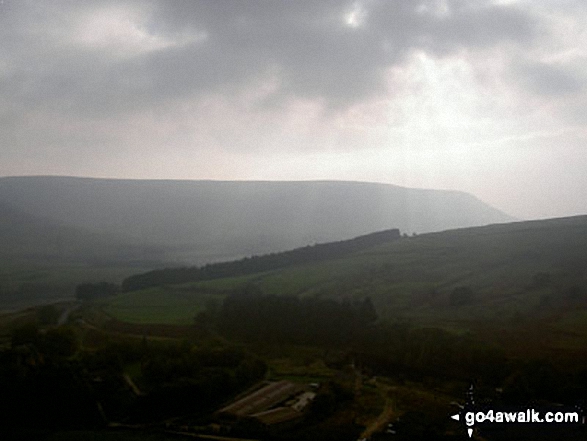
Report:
0,177,512,264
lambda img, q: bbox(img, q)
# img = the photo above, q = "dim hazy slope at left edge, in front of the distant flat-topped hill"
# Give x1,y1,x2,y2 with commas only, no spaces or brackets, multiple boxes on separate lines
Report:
0,203,163,310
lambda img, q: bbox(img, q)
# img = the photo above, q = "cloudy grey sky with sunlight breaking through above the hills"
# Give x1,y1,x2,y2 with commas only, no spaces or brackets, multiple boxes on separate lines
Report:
0,0,587,219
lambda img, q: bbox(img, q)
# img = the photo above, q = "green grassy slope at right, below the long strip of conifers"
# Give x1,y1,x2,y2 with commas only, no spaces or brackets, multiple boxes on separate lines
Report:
107,216,587,354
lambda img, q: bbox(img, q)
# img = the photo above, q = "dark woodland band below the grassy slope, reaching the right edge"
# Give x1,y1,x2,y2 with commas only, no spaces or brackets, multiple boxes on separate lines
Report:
204,292,587,403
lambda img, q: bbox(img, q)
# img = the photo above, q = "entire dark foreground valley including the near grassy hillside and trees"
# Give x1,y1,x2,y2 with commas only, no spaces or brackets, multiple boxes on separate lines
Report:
2,216,587,441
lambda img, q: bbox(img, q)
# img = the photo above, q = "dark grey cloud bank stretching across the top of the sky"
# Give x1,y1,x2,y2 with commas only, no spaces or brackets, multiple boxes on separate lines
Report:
0,0,535,116
